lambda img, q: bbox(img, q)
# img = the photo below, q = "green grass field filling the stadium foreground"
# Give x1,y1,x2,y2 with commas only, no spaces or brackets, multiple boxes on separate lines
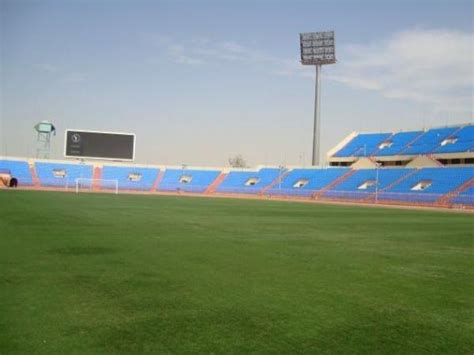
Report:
0,191,474,355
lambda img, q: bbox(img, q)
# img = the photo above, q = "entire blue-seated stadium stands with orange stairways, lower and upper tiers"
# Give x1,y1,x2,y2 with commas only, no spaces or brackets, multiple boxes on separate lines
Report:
0,124,474,209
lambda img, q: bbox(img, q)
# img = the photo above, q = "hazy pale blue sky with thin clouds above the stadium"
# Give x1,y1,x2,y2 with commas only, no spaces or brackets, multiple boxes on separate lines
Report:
0,0,473,165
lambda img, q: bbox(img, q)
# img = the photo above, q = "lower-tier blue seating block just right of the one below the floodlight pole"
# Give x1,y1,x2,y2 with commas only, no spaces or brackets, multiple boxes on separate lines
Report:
324,168,413,199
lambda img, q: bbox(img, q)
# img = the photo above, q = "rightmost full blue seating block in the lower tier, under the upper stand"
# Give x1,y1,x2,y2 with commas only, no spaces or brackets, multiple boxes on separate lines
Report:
379,167,474,202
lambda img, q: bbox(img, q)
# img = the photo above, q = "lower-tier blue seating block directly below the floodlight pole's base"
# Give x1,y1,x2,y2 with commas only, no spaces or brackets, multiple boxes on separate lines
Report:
268,168,349,196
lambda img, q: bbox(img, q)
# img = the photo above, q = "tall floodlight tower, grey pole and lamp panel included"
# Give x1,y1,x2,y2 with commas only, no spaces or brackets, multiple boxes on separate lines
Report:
300,31,336,165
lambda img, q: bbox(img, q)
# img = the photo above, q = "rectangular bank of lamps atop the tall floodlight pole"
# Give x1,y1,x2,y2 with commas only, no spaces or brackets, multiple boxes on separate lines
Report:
300,31,336,65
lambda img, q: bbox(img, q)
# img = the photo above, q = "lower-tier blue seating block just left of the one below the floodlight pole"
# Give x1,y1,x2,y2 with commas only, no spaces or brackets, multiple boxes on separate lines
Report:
216,168,285,194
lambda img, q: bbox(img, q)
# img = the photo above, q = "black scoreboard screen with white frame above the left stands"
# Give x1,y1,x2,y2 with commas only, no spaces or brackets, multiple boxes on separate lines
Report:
64,129,135,160
